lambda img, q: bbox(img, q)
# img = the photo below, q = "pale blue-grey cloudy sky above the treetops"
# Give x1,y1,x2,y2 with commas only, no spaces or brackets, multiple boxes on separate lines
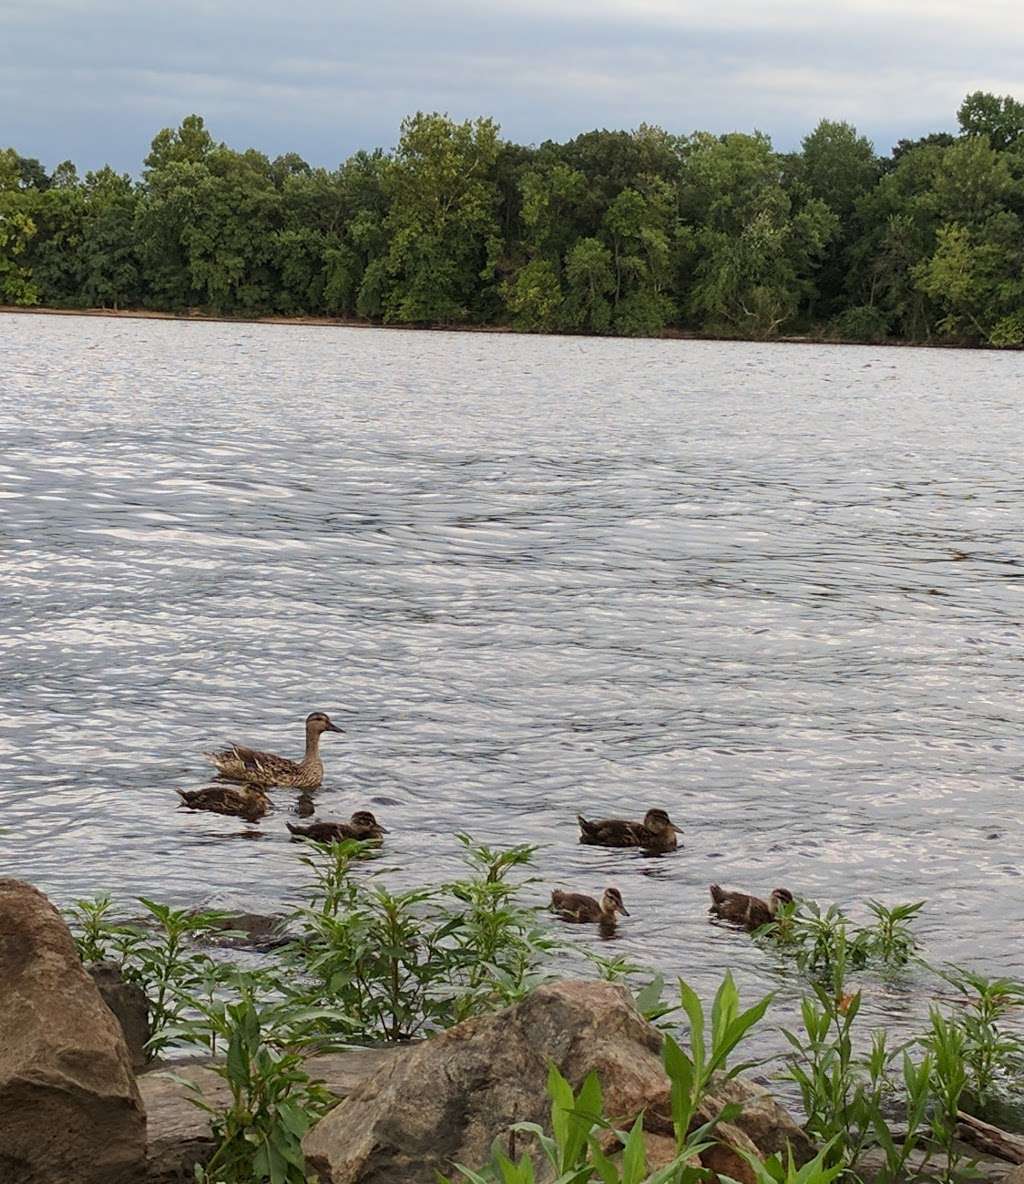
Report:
0,0,1024,173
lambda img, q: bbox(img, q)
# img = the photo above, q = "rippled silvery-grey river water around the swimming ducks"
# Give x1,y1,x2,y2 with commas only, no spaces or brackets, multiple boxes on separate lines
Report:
0,305,1024,1056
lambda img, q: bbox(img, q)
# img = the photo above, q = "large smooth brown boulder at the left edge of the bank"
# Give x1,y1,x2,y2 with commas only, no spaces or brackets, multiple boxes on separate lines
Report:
0,880,146,1184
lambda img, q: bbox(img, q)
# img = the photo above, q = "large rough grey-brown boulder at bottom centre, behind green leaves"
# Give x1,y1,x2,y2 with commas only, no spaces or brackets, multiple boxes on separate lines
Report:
304,983,806,1184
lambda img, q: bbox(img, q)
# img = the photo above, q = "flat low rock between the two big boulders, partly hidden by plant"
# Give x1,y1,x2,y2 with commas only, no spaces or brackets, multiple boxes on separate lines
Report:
139,1048,404,1184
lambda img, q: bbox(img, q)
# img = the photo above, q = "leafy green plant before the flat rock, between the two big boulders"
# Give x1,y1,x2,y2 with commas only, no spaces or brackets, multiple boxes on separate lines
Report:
186,982,335,1184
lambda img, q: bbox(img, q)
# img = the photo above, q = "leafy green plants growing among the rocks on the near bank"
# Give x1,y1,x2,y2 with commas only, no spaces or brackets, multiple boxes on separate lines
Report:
70,836,1024,1184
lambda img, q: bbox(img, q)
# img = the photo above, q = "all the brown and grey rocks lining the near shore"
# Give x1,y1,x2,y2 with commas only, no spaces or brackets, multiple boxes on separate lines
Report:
0,880,1024,1184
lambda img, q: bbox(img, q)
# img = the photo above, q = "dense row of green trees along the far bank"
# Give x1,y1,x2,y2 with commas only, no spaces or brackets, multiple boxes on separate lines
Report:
0,91,1024,346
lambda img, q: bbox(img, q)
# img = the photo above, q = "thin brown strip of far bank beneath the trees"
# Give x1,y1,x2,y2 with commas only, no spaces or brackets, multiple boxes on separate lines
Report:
0,304,1008,353
